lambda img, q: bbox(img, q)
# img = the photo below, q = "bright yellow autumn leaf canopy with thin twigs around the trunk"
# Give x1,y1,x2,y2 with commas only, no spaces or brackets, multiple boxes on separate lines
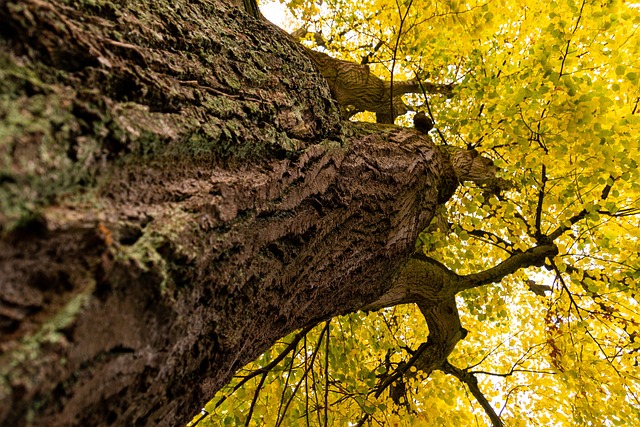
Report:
198,0,640,426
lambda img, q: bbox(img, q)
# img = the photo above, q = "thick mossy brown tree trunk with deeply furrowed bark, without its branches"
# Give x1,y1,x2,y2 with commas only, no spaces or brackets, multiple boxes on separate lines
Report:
0,0,451,426
